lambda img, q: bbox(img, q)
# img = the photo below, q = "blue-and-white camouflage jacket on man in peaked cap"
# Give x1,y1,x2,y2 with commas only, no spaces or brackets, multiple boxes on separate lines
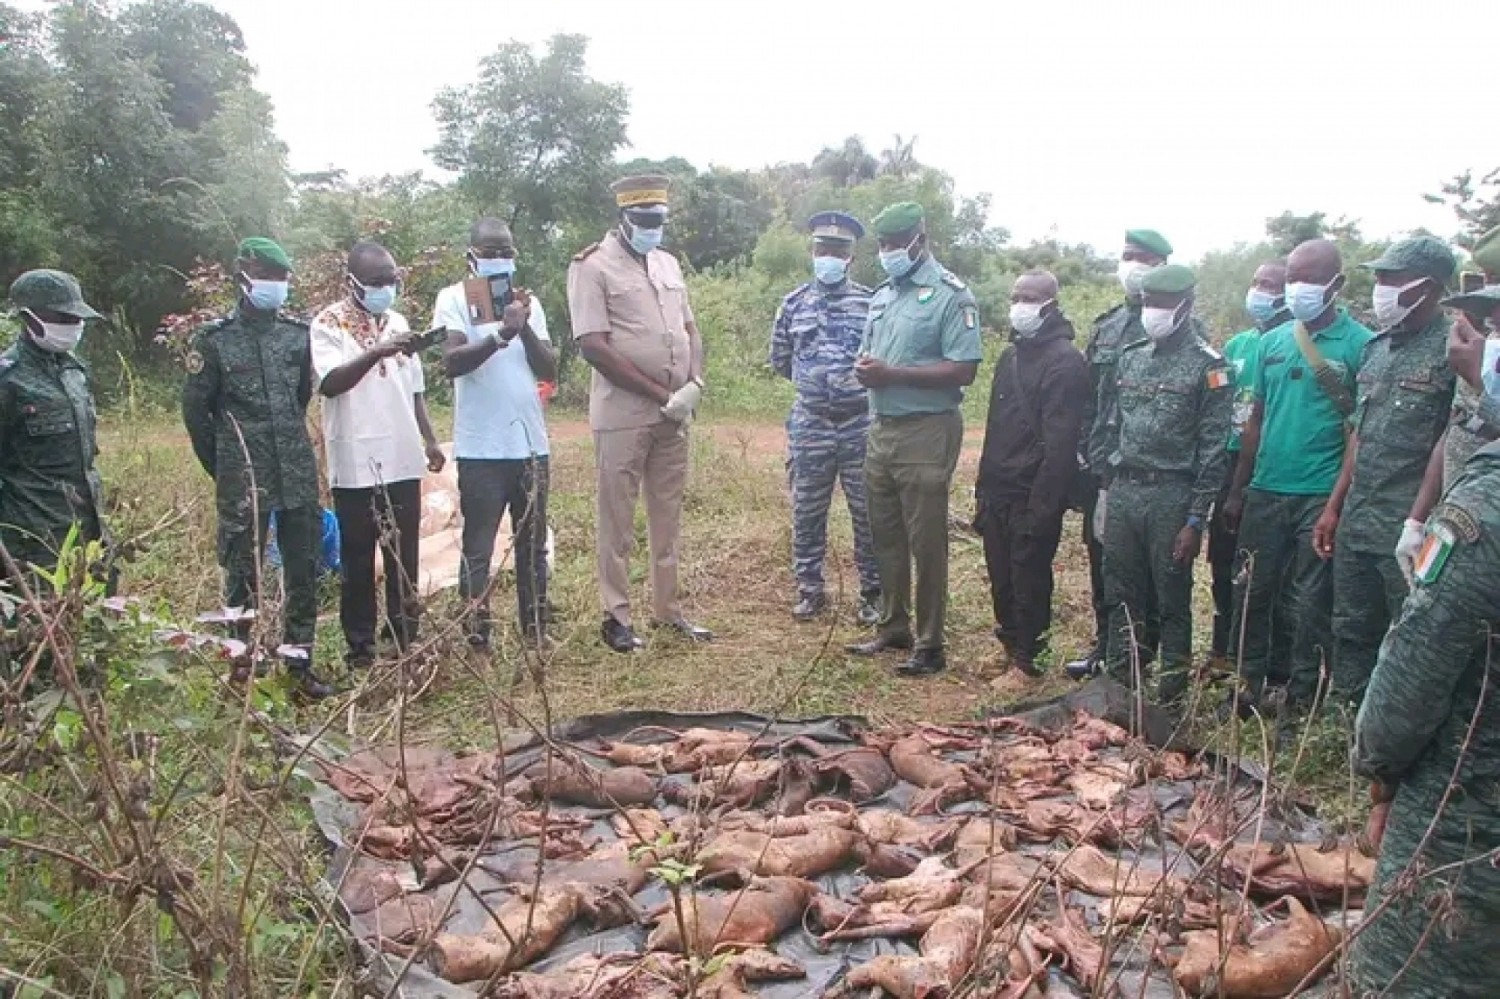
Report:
771,281,870,419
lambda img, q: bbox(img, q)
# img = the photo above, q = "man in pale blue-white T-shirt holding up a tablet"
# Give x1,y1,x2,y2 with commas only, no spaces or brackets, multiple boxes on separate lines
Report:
432,219,558,650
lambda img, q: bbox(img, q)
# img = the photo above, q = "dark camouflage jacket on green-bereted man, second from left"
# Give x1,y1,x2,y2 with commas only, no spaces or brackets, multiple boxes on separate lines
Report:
183,312,318,525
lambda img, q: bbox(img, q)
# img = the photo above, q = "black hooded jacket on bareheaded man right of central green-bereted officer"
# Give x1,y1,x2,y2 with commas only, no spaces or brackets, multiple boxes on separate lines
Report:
978,312,1091,518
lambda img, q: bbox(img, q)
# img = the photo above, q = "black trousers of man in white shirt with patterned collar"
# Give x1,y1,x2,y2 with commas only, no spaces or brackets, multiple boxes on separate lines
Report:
333,479,422,659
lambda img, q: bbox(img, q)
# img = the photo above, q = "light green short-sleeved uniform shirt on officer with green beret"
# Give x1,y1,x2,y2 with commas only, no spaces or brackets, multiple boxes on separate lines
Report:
860,257,984,417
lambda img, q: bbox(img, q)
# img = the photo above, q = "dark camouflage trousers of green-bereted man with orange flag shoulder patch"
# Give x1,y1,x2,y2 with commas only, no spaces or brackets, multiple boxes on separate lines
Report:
1104,476,1193,696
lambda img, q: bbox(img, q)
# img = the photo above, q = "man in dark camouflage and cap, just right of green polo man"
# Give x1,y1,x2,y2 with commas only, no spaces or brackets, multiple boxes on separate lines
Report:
1313,236,1457,704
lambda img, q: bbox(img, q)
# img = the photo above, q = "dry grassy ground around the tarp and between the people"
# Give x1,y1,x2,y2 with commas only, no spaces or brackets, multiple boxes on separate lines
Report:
0,396,1359,998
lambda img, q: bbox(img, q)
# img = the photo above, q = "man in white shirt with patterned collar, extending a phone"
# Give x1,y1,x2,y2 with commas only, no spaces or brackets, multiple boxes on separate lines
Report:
312,243,444,668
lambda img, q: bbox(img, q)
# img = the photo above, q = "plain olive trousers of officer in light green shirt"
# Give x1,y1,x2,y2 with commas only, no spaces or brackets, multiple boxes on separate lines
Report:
864,413,963,650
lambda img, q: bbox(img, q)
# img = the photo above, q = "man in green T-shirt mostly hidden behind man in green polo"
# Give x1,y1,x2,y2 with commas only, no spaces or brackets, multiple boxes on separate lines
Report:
1209,260,1292,669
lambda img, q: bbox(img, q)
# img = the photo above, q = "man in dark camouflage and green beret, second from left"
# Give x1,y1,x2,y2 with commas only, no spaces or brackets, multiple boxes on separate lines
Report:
183,239,333,699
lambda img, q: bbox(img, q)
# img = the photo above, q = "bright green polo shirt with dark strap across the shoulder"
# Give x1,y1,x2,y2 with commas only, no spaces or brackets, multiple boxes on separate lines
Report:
1250,306,1376,497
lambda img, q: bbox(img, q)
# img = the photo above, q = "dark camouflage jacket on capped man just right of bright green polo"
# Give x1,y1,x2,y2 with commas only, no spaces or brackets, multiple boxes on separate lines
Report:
1338,315,1455,555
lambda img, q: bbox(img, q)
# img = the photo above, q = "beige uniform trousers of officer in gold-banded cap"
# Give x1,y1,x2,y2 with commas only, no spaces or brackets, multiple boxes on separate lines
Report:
594,420,689,626
